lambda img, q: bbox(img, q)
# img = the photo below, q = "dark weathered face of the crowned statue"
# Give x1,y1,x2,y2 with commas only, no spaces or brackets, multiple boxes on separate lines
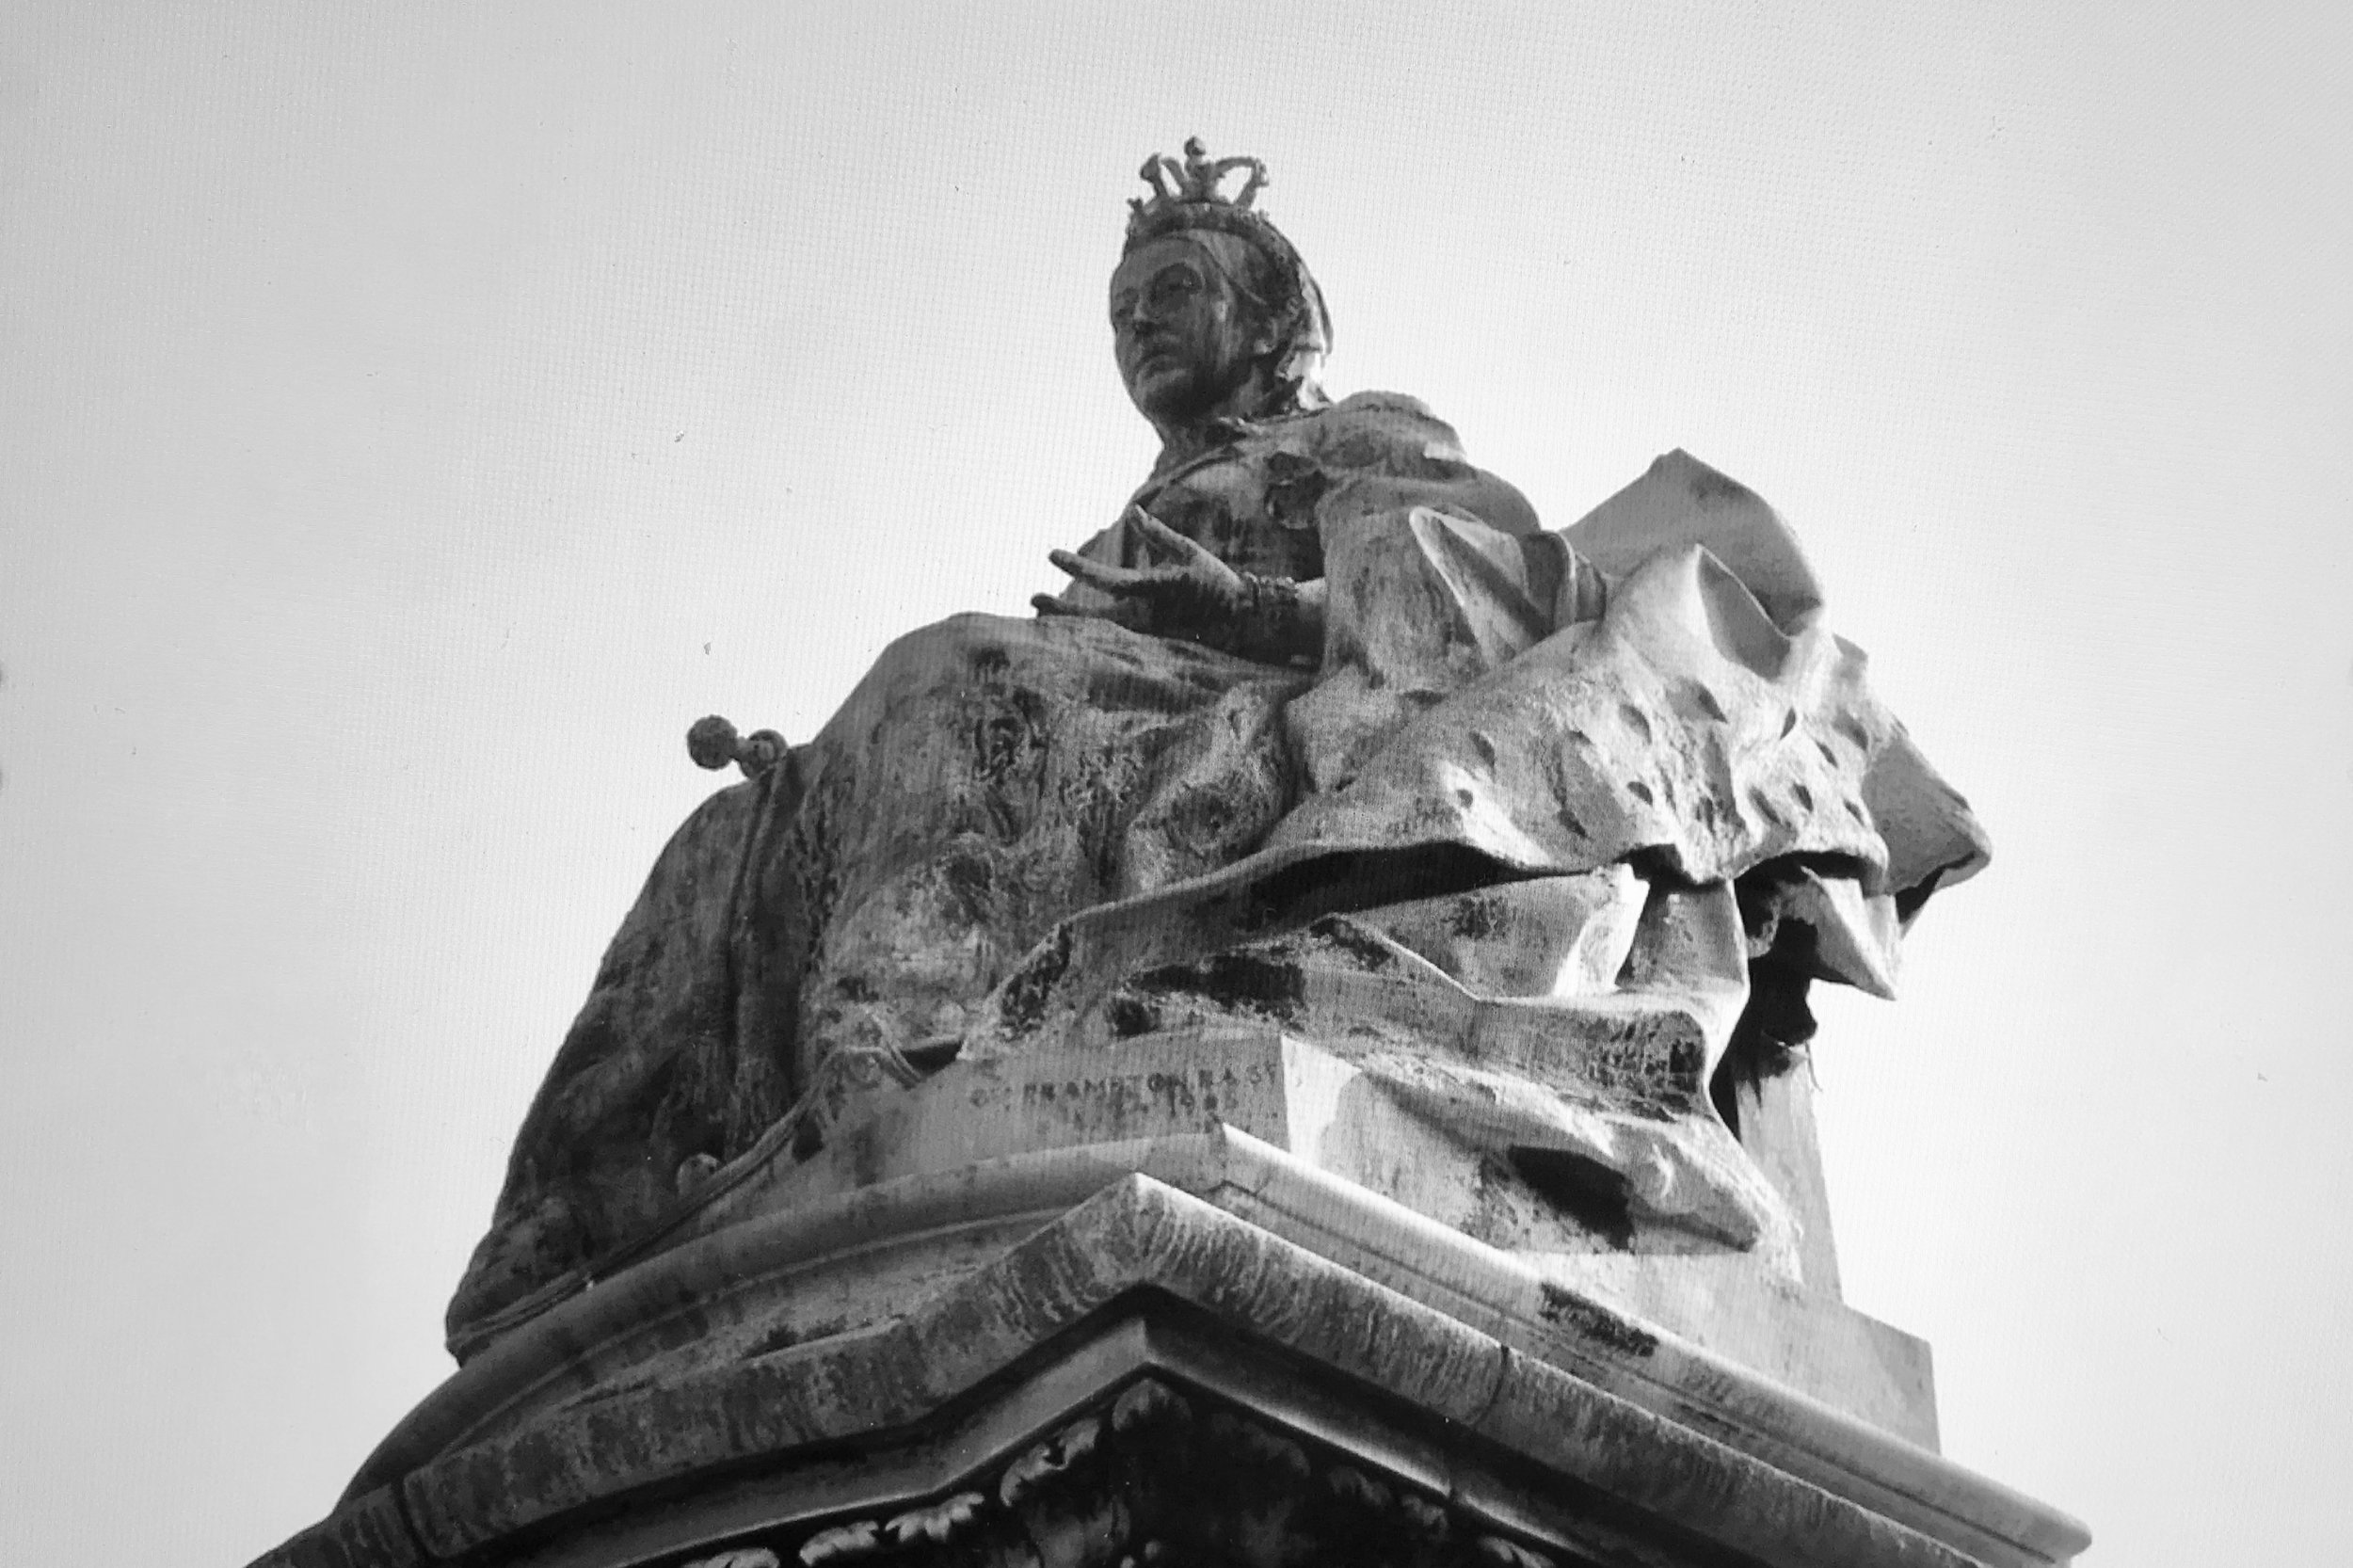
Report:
1111,235,1273,426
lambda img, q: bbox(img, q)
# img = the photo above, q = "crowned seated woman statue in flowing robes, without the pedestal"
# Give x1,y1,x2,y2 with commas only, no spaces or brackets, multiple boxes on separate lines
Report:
450,144,1986,1356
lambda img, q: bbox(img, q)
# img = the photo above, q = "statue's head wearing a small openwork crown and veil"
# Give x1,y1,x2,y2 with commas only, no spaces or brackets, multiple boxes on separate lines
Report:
1111,139,1332,433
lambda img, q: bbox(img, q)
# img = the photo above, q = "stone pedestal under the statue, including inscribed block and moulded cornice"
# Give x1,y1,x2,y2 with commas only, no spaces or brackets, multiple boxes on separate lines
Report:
257,1029,2088,1568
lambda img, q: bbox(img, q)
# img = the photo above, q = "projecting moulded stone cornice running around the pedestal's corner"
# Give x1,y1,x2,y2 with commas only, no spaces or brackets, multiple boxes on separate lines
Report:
262,1135,2088,1568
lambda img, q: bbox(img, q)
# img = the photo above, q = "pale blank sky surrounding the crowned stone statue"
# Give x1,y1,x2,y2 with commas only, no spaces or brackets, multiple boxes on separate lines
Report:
0,0,2353,1568
